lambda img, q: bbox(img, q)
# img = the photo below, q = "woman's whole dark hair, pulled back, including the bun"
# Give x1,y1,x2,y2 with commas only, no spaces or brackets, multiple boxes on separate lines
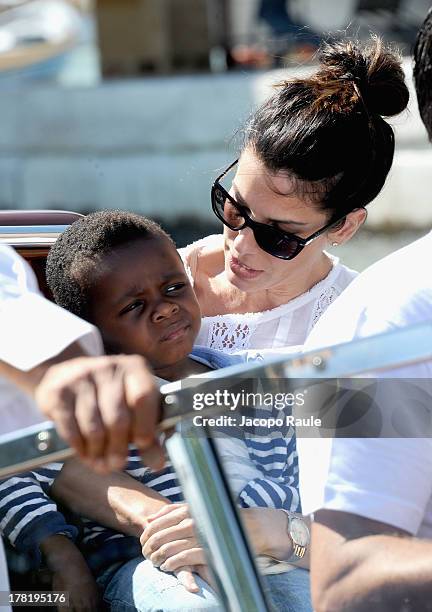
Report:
244,37,409,219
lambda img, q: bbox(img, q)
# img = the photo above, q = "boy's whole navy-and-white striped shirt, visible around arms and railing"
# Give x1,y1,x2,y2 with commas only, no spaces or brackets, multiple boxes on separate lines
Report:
0,347,301,571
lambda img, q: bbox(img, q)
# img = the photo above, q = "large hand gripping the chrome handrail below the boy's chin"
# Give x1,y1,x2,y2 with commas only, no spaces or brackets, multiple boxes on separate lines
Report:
35,355,163,472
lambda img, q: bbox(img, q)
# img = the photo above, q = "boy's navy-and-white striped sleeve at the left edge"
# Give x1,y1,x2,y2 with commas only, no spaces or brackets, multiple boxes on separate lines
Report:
0,463,78,567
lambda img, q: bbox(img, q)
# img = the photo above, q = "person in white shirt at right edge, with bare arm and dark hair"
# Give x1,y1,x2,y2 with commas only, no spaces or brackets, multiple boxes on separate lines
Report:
298,10,432,612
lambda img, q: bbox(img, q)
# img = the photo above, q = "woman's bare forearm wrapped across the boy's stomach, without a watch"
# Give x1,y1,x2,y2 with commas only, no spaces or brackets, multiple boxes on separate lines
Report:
51,459,171,537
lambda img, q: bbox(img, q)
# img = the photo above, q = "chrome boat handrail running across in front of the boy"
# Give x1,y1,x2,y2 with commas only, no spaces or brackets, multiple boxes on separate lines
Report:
0,321,432,478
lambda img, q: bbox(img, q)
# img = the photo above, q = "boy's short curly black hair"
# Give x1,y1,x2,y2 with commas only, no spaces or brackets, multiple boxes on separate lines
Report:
46,210,175,321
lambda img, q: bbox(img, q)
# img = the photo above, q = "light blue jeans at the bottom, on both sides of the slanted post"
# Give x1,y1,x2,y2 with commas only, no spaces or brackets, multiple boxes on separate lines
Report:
98,557,312,612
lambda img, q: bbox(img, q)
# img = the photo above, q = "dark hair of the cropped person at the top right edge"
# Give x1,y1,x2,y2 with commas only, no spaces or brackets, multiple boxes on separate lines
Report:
414,8,432,141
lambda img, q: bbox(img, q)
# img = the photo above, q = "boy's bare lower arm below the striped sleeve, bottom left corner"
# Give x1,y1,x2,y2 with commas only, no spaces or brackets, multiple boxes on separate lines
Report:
40,535,100,612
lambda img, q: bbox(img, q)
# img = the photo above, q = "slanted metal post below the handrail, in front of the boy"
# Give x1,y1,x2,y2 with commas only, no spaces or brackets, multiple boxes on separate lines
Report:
166,422,270,612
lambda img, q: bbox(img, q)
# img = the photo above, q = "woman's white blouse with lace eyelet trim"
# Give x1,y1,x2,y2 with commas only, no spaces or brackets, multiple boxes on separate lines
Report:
179,234,357,353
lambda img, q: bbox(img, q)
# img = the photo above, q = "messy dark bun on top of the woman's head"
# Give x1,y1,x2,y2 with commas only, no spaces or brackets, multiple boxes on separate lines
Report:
315,36,409,117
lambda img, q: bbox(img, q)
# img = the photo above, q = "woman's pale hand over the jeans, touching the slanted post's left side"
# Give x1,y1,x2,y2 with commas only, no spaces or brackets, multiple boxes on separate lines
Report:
140,503,211,593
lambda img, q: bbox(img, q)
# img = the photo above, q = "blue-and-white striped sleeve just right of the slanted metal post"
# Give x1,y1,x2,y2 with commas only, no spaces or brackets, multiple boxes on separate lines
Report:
238,437,301,512
